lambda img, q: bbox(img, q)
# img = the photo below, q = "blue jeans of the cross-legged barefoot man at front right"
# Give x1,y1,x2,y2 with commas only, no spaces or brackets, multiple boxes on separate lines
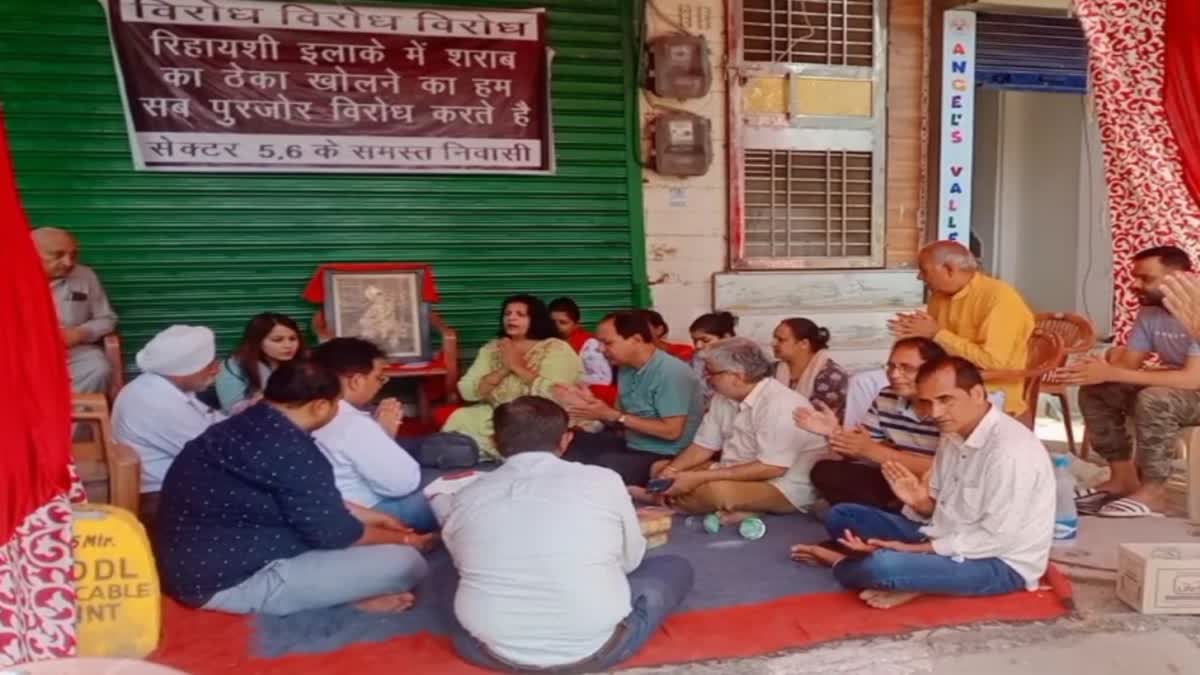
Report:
826,504,1025,596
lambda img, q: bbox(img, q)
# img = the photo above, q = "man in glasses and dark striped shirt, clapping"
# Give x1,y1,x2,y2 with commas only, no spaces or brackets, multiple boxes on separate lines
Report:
794,338,946,512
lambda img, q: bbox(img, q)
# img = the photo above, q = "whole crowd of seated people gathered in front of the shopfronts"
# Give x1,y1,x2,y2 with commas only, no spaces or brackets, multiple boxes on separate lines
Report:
46,231,1200,671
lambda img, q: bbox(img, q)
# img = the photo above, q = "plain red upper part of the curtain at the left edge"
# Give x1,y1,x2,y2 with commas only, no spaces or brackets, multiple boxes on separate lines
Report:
0,109,71,543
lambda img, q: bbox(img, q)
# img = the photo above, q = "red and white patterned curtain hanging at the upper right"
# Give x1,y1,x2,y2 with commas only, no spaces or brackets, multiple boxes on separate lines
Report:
1075,0,1200,338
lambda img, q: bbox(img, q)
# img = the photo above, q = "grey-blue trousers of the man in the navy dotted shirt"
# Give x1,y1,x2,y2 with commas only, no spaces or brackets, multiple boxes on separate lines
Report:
204,544,428,616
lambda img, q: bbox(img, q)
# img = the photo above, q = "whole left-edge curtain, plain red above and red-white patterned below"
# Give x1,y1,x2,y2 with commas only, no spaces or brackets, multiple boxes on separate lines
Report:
0,107,82,668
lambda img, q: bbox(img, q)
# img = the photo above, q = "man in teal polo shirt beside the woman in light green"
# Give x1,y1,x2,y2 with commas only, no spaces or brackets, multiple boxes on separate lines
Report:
563,311,704,485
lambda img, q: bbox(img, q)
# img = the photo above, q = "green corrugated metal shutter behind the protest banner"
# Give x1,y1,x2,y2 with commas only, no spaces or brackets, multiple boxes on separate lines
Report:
0,0,648,353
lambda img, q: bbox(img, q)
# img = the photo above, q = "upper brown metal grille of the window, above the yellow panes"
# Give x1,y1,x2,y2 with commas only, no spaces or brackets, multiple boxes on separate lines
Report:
742,0,873,66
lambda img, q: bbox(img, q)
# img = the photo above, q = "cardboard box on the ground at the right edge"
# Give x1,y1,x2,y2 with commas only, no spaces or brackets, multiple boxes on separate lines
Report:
1117,543,1200,614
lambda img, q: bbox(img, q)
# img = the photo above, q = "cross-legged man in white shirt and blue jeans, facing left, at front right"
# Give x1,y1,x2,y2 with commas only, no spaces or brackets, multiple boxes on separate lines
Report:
792,357,1055,608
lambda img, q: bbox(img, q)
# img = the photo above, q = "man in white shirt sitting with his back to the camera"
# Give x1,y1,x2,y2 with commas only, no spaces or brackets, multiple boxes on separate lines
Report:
442,396,694,673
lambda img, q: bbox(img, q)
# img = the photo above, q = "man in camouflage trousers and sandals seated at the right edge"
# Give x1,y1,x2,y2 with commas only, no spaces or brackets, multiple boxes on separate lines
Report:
1063,246,1200,518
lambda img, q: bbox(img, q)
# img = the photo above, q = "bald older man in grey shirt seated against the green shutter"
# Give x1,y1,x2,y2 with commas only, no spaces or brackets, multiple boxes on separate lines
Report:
32,227,116,394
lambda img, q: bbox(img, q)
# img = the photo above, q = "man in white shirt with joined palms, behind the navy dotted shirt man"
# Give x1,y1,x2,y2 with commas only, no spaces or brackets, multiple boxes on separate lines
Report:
312,338,437,532
